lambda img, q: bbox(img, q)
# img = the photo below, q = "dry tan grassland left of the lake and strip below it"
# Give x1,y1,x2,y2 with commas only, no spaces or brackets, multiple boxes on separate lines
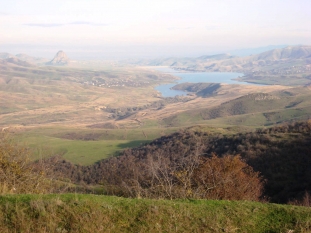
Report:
0,63,288,127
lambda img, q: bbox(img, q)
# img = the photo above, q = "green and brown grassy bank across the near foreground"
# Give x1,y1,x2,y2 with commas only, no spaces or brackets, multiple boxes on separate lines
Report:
0,194,311,233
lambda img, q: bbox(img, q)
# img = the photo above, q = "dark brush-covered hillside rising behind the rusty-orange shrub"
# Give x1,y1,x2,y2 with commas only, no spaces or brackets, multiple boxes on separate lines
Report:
47,120,311,203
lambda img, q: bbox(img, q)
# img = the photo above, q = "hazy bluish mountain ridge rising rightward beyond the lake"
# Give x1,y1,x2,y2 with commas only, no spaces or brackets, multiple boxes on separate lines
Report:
132,45,311,71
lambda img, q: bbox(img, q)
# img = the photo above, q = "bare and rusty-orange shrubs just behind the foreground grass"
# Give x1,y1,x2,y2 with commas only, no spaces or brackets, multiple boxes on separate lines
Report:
105,142,263,200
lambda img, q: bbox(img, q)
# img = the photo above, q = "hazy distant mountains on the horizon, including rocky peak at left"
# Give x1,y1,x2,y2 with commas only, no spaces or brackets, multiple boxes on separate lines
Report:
0,45,311,71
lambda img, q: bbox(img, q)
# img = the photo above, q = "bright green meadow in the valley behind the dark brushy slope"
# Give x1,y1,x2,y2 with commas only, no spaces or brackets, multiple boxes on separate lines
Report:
15,127,178,165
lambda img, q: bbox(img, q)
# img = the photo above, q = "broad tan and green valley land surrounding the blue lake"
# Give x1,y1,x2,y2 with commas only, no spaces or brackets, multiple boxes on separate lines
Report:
0,47,311,164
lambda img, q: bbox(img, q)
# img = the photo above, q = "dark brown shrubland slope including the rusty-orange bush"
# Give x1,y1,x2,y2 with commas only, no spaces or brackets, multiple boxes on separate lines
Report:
46,121,311,203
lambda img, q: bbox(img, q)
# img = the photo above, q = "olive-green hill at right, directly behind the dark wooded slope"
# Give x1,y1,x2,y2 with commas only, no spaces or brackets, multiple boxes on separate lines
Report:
163,87,311,127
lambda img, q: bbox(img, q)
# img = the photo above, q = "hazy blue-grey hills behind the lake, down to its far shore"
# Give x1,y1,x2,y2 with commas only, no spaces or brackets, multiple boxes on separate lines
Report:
130,45,311,81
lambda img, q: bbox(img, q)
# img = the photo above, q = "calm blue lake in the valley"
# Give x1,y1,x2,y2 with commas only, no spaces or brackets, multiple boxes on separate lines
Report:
154,67,249,97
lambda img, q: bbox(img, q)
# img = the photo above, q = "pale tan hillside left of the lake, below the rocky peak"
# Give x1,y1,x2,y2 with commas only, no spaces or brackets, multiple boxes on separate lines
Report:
0,57,178,126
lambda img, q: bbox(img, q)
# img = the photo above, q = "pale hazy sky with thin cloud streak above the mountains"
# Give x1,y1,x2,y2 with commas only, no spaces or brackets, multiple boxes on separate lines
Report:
0,0,311,59
